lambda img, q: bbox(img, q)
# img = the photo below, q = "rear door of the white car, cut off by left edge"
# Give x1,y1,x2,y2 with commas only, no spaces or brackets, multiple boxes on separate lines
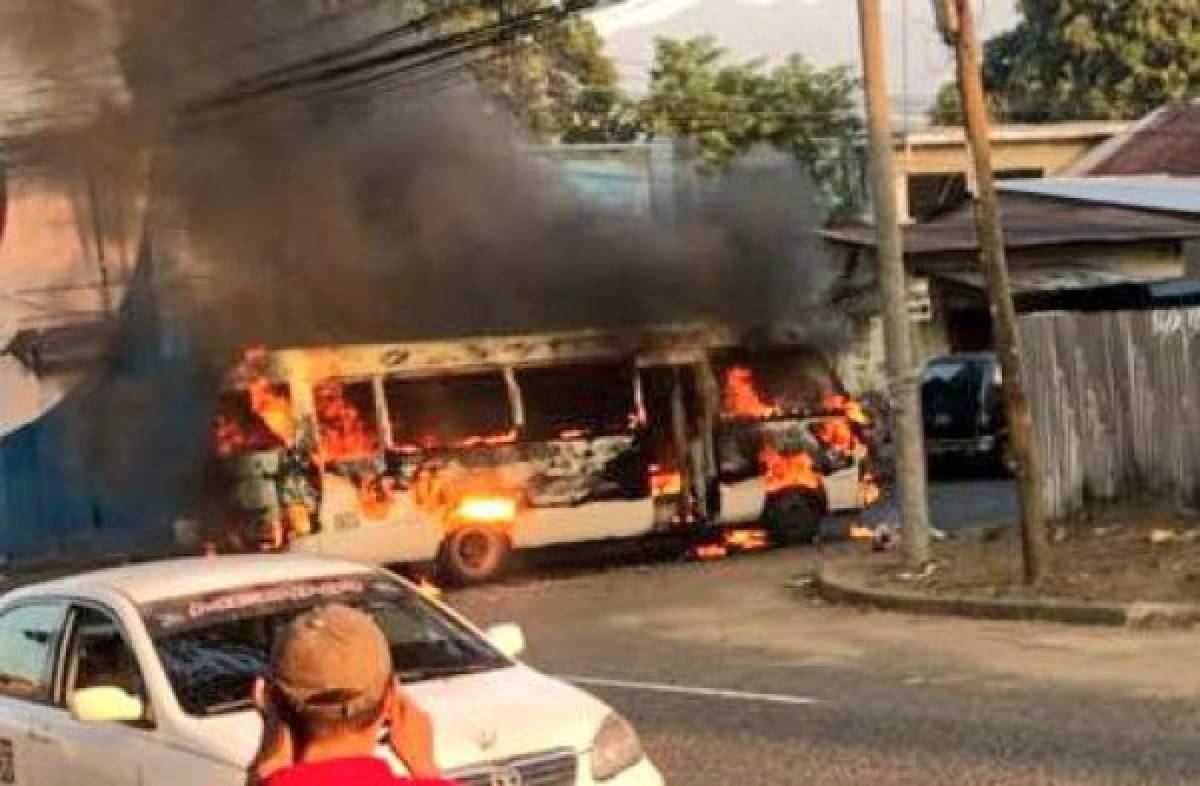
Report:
0,601,66,786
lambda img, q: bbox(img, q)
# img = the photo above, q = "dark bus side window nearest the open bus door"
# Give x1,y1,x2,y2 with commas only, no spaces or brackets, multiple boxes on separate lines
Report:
517,365,637,440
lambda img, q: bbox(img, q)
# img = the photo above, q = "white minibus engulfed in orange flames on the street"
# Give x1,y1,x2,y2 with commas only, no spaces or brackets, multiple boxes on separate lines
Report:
214,324,875,582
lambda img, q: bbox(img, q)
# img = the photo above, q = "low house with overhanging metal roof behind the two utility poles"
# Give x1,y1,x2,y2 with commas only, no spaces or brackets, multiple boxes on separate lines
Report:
822,179,1200,388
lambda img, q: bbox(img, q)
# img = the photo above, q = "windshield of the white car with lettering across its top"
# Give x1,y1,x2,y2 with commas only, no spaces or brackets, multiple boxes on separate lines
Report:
143,575,511,715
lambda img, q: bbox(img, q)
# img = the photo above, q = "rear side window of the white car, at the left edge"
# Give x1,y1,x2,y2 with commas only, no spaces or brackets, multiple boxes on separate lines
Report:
0,604,65,702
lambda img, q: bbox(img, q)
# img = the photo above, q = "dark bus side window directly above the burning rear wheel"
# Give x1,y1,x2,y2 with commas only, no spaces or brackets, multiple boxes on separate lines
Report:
384,372,515,449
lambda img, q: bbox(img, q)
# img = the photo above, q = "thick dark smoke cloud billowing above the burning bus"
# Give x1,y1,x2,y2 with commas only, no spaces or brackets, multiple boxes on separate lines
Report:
0,0,838,535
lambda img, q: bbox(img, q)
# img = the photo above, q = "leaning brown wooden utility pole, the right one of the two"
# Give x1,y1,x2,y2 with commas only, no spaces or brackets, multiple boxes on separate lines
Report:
934,0,1046,584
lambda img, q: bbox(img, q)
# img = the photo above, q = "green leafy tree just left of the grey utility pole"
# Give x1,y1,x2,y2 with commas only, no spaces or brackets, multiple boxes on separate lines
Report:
641,36,863,204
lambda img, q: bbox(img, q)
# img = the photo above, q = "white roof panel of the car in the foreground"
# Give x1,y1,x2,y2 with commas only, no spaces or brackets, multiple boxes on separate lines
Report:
13,554,372,605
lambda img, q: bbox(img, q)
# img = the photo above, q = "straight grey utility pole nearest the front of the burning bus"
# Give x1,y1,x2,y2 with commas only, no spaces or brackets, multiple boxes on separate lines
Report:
858,0,929,566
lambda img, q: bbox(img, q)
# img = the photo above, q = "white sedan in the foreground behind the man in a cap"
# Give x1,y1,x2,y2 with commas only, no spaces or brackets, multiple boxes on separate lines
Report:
0,556,662,786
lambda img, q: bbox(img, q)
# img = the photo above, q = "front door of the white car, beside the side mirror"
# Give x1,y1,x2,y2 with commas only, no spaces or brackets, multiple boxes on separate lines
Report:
34,604,154,786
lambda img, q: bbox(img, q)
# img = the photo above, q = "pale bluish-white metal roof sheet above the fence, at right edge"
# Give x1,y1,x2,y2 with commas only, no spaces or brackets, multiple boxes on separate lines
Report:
996,176,1200,216
